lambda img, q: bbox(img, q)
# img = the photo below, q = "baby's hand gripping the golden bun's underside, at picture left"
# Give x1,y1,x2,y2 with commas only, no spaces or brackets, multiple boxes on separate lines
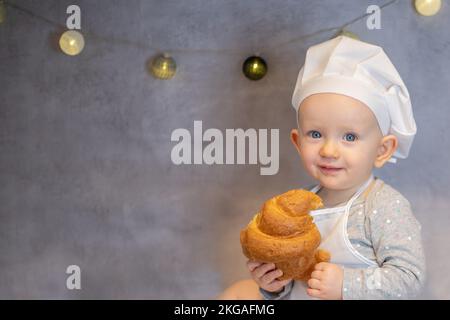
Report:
247,260,292,292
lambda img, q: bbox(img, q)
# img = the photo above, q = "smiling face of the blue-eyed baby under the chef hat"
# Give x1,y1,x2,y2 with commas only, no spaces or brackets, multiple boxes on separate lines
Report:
297,93,383,189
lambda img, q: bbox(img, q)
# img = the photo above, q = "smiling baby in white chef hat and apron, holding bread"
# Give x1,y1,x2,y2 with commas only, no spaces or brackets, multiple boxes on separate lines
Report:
247,36,425,299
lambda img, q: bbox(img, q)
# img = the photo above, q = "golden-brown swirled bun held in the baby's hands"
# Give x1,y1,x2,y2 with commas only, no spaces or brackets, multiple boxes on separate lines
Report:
240,189,330,281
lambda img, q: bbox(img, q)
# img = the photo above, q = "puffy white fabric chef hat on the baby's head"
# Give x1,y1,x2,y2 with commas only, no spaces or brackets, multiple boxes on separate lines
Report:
292,36,417,163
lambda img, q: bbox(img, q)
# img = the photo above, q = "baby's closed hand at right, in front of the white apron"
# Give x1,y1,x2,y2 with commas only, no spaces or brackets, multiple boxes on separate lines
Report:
306,262,344,300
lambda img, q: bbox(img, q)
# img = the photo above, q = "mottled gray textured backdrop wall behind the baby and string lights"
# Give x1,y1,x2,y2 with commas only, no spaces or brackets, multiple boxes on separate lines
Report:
0,0,450,299
